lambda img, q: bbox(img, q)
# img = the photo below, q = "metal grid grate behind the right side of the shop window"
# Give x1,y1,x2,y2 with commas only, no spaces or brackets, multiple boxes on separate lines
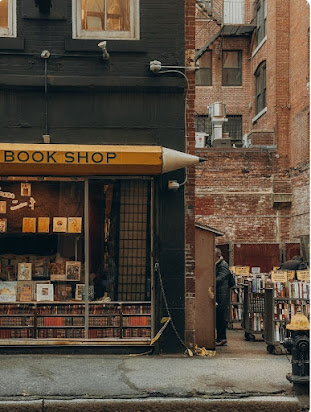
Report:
118,180,150,301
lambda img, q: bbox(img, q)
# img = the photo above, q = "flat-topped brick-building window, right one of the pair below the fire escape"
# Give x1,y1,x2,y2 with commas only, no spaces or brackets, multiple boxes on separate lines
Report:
222,50,242,86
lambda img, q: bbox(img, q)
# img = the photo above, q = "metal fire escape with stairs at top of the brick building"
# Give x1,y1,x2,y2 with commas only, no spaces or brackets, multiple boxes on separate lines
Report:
195,0,256,60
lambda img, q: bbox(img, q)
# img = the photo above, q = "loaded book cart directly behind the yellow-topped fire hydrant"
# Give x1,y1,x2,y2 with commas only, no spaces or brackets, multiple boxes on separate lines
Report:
265,273,310,355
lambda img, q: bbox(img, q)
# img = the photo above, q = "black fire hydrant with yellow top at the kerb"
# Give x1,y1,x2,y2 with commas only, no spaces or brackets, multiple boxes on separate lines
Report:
283,312,310,384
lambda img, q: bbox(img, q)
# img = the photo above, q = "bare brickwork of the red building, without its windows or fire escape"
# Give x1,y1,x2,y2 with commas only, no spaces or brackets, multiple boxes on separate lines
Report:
195,0,309,256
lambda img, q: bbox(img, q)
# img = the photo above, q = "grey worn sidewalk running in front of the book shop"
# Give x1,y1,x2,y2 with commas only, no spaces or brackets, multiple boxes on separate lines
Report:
0,330,309,412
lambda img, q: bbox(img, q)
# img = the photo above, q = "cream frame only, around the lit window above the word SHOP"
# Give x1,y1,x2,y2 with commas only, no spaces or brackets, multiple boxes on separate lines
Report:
72,0,140,40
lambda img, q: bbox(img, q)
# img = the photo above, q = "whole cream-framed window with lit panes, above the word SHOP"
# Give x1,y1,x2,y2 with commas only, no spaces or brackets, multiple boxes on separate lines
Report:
72,0,139,40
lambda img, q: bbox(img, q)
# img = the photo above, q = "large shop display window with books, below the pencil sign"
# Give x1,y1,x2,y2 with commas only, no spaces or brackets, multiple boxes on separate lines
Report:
0,177,152,340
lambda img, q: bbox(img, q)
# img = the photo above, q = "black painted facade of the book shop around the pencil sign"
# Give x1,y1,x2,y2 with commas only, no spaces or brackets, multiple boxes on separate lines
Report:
0,0,186,351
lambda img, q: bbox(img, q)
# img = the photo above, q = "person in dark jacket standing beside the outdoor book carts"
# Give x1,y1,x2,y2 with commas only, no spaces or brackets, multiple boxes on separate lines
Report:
215,248,230,346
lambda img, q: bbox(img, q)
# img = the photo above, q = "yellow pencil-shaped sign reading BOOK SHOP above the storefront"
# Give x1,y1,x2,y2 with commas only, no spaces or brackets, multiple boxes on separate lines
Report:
0,143,205,176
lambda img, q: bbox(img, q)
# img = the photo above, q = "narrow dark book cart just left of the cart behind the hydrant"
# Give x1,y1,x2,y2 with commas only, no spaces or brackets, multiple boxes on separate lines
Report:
242,275,266,341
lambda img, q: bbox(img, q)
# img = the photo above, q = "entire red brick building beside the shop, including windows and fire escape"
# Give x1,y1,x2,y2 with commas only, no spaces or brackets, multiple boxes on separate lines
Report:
195,0,309,271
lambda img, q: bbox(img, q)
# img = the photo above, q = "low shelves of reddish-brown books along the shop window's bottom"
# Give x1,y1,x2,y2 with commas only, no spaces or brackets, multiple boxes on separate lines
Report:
0,301,151,340
